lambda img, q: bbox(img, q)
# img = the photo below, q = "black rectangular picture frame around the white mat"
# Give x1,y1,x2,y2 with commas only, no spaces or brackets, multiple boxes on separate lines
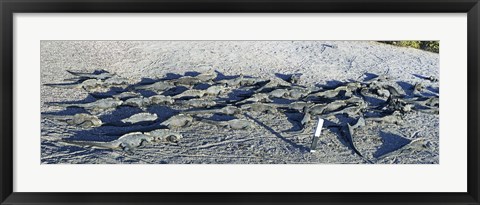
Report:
0,0,480,204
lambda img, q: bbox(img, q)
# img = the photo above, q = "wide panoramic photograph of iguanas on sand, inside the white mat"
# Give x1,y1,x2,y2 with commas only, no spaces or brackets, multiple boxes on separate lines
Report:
40,40,440,164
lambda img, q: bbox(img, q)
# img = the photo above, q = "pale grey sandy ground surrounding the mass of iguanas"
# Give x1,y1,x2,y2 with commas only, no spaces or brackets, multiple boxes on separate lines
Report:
41,41,439,164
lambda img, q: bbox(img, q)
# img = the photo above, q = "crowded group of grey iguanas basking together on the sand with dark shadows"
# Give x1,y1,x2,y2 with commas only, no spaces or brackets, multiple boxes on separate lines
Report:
43,71,439,162
